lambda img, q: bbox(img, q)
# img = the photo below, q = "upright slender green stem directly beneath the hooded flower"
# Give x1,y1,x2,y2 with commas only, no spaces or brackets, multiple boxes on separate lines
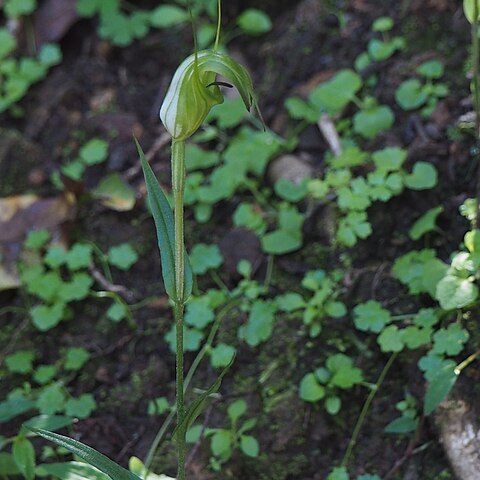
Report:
172,140,186,480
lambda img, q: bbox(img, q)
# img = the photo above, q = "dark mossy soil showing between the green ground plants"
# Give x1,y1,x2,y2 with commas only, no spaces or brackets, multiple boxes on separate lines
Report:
0,0,476,480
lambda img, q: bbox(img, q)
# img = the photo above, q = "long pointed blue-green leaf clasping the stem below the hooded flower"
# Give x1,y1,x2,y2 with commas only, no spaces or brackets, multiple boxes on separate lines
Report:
135,139,193,302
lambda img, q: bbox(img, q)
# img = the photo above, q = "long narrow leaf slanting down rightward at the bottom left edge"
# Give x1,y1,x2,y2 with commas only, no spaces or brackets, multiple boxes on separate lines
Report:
27,427,141,480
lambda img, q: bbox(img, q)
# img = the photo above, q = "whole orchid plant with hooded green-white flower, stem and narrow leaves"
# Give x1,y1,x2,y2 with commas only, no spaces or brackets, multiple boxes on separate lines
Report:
26,0,259,480
